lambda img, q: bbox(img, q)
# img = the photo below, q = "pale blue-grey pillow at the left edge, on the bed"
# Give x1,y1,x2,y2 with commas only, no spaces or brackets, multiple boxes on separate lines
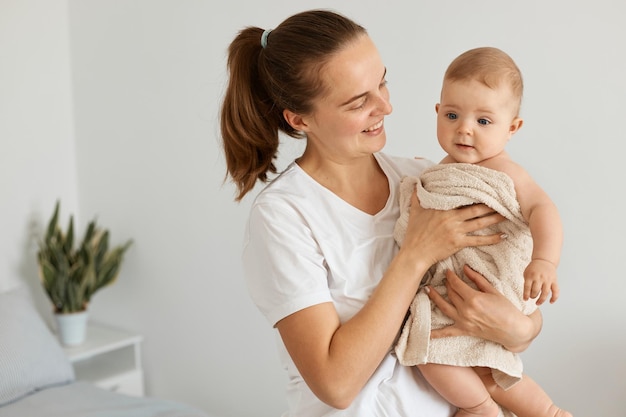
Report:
0,289,74,406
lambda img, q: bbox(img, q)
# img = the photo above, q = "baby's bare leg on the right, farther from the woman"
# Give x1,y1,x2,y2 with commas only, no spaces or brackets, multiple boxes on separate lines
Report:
475,368,572,417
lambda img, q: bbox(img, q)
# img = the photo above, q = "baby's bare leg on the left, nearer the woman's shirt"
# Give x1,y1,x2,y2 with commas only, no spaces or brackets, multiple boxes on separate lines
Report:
418,363,499,417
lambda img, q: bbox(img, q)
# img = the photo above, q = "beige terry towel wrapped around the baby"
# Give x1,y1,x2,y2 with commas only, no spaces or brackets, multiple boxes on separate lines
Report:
394,164,536,389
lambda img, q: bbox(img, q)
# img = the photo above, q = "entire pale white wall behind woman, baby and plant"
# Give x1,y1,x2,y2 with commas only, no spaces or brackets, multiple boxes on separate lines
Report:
0,0,626,417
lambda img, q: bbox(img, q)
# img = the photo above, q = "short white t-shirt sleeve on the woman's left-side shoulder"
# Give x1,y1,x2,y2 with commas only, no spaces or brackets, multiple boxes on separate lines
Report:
243,197,332,326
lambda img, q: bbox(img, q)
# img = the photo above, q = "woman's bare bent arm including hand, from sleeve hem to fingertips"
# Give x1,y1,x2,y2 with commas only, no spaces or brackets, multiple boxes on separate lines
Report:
276,196,502,408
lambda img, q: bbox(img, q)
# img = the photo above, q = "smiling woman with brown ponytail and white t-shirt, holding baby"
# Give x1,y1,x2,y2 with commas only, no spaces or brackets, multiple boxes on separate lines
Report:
221,10,541,417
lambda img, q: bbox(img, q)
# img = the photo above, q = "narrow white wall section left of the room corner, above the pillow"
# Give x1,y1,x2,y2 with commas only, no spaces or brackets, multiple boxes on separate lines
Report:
0,0,78,306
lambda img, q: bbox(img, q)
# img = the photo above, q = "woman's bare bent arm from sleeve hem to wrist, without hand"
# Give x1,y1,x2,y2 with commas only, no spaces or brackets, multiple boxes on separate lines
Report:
276,247,429,409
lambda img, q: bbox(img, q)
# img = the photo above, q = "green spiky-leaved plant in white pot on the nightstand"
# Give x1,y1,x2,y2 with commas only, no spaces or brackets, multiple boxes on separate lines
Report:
37,201,132,346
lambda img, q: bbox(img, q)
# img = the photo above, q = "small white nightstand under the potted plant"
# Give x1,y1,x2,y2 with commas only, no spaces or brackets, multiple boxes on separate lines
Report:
63,323,144,397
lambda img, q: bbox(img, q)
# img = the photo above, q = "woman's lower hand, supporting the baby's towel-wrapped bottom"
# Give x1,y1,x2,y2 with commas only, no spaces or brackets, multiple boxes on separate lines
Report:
427,266,542,352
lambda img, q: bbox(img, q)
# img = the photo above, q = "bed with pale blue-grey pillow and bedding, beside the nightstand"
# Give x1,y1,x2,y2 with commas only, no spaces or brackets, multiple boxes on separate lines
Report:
0,287,215,417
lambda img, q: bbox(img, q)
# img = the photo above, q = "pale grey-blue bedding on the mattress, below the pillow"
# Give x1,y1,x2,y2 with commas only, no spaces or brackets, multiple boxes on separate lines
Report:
0,381,211,417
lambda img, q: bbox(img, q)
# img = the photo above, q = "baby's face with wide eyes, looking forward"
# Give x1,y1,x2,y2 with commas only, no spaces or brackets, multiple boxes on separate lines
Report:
435,80,520,164
